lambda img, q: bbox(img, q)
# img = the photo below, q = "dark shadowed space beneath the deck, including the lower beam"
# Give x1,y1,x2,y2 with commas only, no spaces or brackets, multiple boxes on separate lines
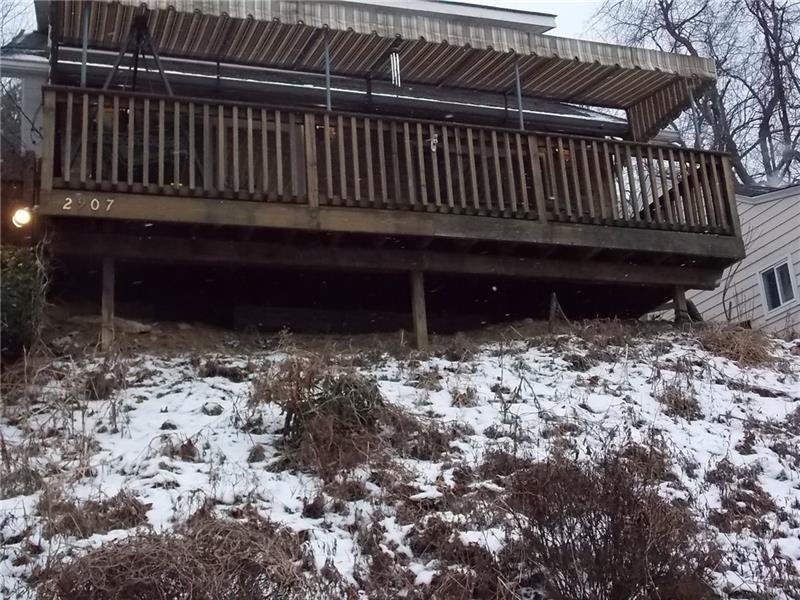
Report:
48,218,732,333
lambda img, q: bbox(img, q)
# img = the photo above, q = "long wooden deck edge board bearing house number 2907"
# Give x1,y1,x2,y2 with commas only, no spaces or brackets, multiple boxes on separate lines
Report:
38,190,744,262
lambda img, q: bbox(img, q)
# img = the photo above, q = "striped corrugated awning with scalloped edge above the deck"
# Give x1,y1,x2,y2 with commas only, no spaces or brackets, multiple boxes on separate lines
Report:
40,0,715,139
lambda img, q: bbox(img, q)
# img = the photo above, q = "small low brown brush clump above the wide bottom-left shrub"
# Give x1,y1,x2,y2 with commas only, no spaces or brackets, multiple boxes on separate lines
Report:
37,487,150,538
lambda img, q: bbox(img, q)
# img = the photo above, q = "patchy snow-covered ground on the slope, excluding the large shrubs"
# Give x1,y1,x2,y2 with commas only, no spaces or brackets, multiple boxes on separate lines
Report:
0,332,800,599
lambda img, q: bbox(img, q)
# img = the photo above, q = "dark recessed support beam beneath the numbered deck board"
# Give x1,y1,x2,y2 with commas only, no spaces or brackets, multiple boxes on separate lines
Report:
50,228,720,289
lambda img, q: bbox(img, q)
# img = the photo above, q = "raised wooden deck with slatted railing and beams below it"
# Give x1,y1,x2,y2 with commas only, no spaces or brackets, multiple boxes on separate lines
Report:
38,87,743,296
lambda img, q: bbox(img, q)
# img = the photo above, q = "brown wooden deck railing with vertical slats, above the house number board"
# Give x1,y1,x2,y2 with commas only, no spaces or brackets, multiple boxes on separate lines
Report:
42,88,736,234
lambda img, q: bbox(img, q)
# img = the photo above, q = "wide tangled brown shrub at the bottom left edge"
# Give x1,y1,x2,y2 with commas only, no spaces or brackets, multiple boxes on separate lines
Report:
37,510,316,600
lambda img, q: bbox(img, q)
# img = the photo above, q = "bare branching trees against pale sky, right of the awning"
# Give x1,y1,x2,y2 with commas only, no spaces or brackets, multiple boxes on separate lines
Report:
595,0,800,184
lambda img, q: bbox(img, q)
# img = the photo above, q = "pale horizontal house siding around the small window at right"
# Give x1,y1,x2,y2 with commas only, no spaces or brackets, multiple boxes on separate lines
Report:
688,186,800,336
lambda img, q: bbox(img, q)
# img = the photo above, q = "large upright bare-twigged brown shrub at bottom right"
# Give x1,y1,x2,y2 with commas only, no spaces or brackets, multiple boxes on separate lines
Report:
500,452,717,600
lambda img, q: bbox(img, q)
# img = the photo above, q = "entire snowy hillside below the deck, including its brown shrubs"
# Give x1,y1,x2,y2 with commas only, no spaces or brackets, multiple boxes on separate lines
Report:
0,327,800,600
